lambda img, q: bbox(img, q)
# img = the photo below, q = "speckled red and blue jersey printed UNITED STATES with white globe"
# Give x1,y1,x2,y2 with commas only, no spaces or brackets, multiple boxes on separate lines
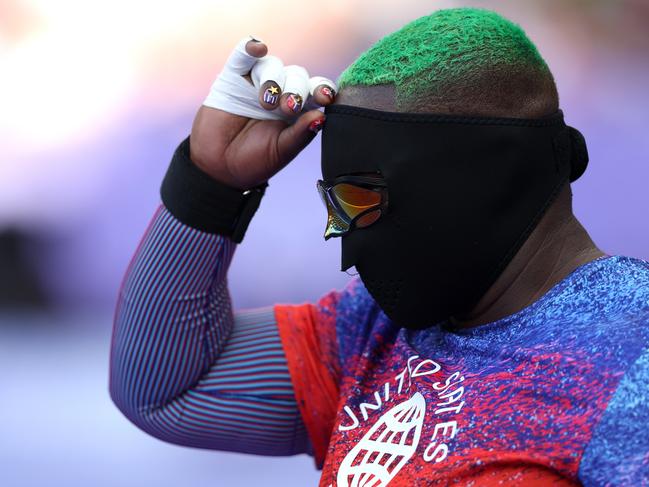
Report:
275,257,649,487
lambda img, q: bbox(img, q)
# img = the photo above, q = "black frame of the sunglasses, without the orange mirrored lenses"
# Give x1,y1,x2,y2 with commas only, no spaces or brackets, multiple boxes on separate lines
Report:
316,173,388,239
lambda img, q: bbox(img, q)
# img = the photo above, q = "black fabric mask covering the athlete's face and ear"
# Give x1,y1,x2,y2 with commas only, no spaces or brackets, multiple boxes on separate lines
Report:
322,105,588,328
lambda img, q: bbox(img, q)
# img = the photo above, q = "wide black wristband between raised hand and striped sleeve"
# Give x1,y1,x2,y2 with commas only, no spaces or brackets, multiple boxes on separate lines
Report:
160,137,268,243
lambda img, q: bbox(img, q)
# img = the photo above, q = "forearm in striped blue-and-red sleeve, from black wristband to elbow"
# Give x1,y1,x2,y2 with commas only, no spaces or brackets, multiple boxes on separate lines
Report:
110,207,234,418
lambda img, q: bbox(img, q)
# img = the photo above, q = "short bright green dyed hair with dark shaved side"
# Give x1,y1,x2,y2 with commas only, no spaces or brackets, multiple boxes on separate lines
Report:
338,8,558,116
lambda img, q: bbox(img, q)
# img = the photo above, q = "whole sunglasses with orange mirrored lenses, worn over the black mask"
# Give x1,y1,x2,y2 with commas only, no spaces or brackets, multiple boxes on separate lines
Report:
316,174,388,240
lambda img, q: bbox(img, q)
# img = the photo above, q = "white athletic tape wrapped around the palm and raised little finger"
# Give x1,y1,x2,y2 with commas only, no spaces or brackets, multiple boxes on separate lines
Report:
203,37,291,120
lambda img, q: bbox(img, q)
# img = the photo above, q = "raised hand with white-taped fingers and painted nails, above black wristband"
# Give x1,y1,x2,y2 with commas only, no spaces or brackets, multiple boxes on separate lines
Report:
190,38,336,189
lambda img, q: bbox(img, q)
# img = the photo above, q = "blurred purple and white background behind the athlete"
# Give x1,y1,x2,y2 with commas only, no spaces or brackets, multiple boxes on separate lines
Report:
0,0,649,486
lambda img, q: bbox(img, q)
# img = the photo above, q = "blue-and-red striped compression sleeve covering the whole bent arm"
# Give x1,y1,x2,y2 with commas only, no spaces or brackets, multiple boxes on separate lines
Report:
110,206,310,455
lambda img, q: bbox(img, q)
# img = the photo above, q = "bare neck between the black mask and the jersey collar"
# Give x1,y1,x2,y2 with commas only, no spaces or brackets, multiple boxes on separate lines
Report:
451,186,605,328
